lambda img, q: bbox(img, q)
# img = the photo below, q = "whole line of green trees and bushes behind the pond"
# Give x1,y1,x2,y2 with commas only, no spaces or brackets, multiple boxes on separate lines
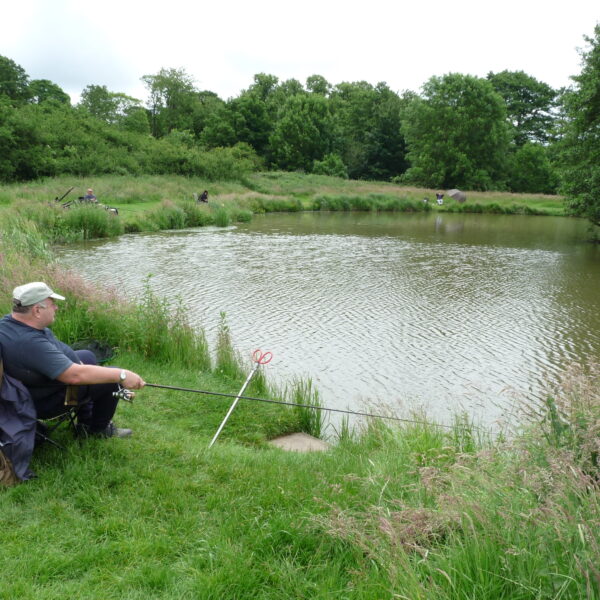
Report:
0,25,600,224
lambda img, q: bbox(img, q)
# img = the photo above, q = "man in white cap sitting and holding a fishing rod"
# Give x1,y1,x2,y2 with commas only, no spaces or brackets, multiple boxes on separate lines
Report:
0,281,145,437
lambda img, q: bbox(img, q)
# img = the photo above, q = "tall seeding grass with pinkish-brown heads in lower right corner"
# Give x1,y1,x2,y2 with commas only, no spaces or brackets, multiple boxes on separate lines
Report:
310,406,600,599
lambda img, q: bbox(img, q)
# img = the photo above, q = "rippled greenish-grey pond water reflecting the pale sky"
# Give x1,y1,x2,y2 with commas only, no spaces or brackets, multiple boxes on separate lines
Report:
59,213,600,425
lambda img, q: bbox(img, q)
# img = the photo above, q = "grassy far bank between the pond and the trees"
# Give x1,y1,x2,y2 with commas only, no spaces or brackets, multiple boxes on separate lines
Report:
0,173,565,243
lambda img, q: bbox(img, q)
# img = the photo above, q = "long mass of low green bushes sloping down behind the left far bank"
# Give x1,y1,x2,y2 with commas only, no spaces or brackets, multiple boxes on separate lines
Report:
0,104,261,181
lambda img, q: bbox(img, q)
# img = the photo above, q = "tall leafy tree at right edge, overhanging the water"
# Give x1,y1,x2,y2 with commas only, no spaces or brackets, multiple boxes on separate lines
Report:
561,24,600,226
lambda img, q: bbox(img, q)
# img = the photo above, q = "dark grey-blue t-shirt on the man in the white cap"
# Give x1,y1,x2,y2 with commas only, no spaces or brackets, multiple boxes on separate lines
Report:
0,315,79,400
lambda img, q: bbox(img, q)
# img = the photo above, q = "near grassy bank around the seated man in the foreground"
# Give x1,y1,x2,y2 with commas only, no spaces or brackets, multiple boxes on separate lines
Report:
0,185,600,600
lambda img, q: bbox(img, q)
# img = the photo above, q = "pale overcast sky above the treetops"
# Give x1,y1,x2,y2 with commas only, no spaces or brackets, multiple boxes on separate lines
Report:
0,0,600,102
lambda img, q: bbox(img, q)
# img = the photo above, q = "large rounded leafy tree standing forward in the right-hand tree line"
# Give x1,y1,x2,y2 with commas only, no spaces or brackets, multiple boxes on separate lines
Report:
403,73,509,189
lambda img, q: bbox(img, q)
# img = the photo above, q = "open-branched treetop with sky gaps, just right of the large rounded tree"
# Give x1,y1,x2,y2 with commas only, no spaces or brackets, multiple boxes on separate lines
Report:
487,71,557,146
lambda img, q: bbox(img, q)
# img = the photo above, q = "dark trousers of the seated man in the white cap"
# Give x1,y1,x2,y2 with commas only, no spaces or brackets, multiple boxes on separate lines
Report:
35,350,119,432
